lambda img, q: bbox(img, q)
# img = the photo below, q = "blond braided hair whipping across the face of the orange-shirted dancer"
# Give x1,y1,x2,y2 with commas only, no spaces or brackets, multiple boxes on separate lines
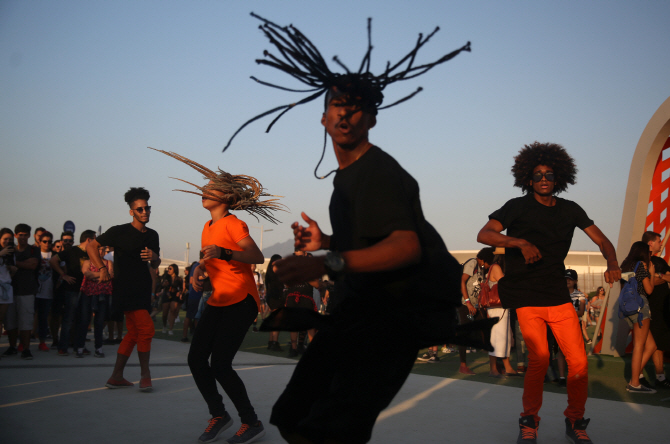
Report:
148,147,286,224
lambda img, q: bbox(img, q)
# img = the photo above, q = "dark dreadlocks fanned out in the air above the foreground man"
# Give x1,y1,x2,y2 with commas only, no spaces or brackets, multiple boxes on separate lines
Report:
223,12,470,179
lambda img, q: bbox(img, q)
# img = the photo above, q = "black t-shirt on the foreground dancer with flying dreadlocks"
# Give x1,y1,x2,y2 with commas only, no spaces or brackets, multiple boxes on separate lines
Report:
329,146,461,310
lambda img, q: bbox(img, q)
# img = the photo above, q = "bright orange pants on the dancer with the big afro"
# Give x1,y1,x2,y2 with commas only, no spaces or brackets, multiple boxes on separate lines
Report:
516,302,589,423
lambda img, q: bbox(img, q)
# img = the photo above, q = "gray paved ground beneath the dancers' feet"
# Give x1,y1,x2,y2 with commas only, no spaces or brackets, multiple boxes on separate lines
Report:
0,338,670,444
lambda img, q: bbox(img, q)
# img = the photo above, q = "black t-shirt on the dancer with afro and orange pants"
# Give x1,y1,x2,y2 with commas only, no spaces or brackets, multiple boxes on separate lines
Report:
489,194,593,308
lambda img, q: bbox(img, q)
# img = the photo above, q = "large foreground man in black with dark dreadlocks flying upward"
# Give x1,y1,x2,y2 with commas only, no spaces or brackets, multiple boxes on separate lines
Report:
224,16,470,443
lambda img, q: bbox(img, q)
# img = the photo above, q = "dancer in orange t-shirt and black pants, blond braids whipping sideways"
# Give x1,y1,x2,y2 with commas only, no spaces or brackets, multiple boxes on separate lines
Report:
150,150,282,444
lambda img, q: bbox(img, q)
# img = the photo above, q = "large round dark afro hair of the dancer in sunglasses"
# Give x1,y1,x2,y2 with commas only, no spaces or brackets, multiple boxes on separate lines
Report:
512,141,577,194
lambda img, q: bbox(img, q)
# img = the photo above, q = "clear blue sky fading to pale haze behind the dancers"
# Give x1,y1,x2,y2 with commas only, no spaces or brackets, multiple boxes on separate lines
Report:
0,0,670,259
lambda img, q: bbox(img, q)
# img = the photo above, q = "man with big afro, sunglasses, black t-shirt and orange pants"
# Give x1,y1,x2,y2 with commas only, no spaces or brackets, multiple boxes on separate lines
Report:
477,142,621,444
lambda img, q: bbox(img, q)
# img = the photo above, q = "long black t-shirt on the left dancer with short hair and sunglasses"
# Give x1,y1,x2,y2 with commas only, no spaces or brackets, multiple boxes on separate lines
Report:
98,223,160,311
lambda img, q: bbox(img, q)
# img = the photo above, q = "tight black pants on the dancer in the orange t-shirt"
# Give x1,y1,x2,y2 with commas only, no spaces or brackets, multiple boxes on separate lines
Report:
188,295,258,424
